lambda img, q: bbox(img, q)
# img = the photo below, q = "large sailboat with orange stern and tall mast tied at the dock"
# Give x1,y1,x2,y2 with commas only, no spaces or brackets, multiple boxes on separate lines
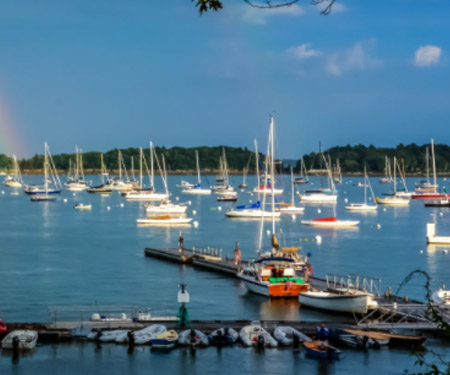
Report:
237,117,309,298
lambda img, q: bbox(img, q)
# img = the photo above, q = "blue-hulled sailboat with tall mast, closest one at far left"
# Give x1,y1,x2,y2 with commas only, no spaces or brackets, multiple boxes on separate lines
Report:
29,142,62,202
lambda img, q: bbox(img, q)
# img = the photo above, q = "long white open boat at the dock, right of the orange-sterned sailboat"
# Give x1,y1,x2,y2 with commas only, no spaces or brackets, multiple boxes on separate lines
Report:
299,292,370,313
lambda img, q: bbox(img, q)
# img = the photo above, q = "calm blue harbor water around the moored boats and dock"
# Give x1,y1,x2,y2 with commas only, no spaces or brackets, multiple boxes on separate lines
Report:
0,176,450,374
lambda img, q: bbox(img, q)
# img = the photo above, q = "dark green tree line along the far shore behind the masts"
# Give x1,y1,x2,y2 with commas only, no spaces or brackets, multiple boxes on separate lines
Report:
0,143,450,173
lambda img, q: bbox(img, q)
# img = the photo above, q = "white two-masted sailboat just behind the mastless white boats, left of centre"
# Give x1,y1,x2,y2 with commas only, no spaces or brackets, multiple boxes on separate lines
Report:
125,142,169,201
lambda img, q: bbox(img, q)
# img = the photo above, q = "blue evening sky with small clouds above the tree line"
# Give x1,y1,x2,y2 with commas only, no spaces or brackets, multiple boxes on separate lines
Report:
0,0,450,158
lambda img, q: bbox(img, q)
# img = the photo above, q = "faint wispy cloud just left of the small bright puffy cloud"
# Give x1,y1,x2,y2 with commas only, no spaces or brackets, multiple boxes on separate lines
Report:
326,41,381,76
